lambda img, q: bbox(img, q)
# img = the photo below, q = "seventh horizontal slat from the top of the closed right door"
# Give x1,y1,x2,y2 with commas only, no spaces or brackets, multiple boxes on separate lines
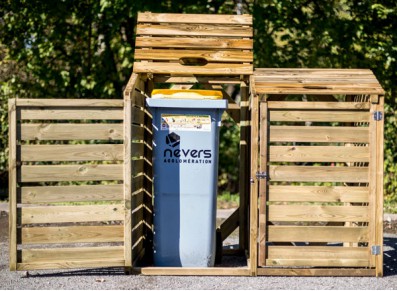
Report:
268,204,369,222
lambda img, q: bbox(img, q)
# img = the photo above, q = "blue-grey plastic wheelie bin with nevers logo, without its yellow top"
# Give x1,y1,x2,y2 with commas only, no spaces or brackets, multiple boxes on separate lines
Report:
146,90,227,267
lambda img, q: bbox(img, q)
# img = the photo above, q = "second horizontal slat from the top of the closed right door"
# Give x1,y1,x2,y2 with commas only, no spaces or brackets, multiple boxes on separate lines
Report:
269,110,370,122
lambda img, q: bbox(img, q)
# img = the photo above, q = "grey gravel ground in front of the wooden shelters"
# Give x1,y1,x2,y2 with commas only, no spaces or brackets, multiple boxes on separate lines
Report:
0,206,397,290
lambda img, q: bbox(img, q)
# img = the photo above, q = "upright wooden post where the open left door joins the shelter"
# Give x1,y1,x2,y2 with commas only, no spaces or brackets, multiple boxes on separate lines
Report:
123,96,133,267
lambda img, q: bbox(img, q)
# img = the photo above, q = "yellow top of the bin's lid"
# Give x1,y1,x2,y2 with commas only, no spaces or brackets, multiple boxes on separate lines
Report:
152,89,223,100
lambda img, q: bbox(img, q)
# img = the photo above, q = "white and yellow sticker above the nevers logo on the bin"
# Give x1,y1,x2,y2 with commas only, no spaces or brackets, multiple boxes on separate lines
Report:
161,114,211,131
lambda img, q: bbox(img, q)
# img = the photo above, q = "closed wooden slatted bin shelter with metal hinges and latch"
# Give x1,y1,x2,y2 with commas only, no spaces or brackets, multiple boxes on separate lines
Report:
250,69,384,276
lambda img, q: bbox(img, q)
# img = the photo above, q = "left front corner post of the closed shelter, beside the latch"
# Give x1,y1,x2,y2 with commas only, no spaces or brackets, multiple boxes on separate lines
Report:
248,95,259,276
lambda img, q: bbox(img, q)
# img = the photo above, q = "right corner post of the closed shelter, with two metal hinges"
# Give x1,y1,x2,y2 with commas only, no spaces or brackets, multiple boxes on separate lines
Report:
375,96,384,277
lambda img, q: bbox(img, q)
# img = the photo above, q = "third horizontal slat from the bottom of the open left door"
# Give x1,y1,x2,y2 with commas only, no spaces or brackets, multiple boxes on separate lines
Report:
21,204,125,224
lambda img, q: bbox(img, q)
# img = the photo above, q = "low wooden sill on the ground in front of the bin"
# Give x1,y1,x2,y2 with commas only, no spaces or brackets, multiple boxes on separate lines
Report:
139,267,251,276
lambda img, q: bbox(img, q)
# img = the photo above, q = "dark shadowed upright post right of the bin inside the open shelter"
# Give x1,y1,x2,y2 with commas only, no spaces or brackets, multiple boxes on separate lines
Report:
239,82,250,250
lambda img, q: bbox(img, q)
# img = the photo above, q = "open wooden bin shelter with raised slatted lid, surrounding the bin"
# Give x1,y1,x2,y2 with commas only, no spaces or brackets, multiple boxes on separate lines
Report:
124,13,253,275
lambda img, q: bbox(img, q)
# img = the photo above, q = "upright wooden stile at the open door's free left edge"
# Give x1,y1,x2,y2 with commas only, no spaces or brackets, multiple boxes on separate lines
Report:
8,99,18,271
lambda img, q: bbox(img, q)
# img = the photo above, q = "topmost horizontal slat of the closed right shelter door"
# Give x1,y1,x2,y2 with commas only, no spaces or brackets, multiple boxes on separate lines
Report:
268,101,370,110
